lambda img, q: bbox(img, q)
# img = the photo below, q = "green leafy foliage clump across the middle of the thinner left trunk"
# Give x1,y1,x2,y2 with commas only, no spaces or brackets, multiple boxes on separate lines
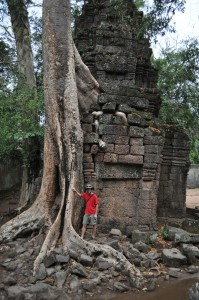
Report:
0,83,43,159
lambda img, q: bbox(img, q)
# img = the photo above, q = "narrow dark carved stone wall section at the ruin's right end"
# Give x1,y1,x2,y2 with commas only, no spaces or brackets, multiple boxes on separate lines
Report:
157,126,190,219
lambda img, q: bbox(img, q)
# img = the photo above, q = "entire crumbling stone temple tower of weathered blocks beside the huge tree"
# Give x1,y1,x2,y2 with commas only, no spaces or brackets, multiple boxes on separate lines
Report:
75,0,189,234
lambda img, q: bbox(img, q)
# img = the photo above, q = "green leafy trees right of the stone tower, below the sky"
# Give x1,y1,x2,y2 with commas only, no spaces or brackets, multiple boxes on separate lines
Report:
153,39,199,163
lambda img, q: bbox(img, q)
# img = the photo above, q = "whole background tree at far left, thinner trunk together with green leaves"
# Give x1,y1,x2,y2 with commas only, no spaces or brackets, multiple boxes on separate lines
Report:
0,0,42,207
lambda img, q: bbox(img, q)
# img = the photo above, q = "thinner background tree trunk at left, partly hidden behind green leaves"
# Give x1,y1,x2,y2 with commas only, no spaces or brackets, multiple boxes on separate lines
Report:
6,0,41,209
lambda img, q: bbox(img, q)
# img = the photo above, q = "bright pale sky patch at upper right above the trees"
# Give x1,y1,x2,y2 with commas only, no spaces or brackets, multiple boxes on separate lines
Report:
152,0,199,57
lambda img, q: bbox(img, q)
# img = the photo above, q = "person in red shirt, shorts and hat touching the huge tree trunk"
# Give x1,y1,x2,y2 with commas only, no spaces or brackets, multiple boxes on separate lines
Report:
73,183,99,239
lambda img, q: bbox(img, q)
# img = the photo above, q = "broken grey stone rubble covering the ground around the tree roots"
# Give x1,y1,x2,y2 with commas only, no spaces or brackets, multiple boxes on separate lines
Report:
0,227,199,300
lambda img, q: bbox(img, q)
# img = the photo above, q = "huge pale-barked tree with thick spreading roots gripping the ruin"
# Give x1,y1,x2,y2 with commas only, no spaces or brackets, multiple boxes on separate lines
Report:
0,0,141,286
